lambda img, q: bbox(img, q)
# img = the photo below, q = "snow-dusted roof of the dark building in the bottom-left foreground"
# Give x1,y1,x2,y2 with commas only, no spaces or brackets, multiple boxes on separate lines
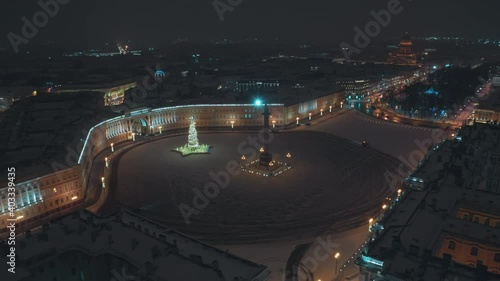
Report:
0,210,269,281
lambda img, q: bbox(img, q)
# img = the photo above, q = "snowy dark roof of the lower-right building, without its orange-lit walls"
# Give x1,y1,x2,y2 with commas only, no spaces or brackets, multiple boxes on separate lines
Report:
365,124,500,281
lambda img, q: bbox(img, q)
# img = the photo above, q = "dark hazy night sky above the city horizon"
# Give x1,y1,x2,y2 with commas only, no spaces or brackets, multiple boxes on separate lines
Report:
0,0,500,48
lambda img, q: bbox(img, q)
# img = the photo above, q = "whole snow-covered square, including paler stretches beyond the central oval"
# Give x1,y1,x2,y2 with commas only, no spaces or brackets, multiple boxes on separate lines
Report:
99,111,444,281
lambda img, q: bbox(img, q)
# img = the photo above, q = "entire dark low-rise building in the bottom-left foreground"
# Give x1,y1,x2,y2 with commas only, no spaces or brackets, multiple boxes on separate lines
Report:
0,210,270,281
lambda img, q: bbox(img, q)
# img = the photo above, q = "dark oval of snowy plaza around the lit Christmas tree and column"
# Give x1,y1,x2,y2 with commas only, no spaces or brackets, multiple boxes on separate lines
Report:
104,131,397,243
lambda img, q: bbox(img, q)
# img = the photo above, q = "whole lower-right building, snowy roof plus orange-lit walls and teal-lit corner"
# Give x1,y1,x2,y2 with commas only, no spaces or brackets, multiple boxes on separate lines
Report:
357,124,500,281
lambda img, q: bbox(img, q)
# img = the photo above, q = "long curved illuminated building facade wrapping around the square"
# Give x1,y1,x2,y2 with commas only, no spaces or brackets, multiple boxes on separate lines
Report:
0,91,345,238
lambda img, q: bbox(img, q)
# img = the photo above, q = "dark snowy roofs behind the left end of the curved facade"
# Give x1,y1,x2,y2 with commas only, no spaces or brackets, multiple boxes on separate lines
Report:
0,92,113,186
